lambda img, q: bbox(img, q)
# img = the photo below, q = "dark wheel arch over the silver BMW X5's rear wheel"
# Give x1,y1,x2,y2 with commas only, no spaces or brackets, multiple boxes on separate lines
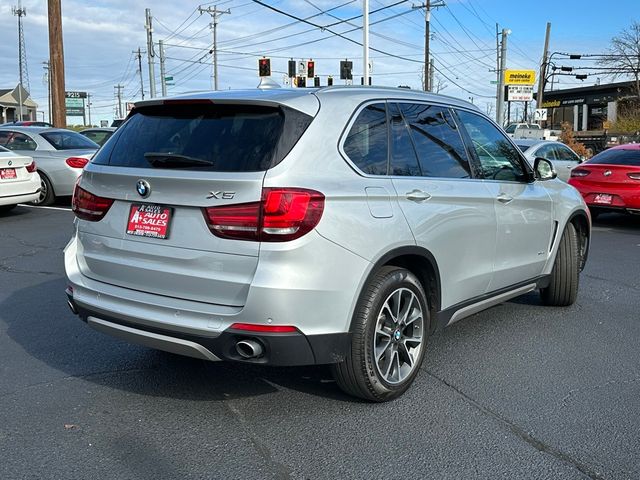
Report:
349,246,442,332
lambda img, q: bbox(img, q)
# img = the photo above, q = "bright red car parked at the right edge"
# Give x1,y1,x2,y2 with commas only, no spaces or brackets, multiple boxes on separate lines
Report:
569,143,640,214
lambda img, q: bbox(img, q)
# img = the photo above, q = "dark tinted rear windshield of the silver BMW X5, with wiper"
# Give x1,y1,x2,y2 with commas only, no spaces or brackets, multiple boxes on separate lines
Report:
93,103,312,172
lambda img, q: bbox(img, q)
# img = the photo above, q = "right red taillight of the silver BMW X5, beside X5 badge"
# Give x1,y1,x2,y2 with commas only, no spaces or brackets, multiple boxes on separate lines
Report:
204,188,324,242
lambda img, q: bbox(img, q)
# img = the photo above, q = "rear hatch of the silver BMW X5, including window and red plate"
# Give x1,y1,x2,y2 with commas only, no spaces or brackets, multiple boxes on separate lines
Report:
74,101,311,306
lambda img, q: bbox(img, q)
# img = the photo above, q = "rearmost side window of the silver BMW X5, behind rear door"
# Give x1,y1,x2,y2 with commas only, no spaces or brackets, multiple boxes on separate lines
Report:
343,103,389,175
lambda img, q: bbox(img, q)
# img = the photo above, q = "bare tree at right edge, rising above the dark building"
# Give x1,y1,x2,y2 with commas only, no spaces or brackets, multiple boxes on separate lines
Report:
599,22,640,98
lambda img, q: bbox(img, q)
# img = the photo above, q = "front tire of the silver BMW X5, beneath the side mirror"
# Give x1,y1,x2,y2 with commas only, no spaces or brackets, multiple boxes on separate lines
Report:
540,222,580,307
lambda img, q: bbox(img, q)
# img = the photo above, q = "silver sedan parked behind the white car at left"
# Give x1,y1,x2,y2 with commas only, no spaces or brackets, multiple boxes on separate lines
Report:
0,124,100,205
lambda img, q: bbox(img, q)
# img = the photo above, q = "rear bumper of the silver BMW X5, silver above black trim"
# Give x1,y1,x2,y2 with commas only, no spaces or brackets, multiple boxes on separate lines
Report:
65,233,370,366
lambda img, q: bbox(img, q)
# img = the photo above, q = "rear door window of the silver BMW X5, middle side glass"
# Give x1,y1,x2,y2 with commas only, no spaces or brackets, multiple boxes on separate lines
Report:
400,103,470,178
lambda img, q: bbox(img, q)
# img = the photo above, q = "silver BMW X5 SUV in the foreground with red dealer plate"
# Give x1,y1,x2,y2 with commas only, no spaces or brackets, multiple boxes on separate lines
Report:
65,87,591,401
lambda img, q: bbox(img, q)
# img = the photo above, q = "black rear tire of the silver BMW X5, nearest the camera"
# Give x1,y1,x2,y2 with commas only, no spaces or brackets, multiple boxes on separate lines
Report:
332,267,429,402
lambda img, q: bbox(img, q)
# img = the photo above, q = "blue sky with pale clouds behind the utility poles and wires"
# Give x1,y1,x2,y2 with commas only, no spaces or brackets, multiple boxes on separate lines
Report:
0,0,640,124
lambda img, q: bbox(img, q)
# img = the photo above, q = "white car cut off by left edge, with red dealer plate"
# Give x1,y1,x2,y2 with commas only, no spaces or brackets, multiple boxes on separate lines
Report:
0,147,40,213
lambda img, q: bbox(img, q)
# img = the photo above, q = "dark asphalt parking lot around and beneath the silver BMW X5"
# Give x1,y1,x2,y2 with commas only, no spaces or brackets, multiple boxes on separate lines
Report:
0,207,640,479
